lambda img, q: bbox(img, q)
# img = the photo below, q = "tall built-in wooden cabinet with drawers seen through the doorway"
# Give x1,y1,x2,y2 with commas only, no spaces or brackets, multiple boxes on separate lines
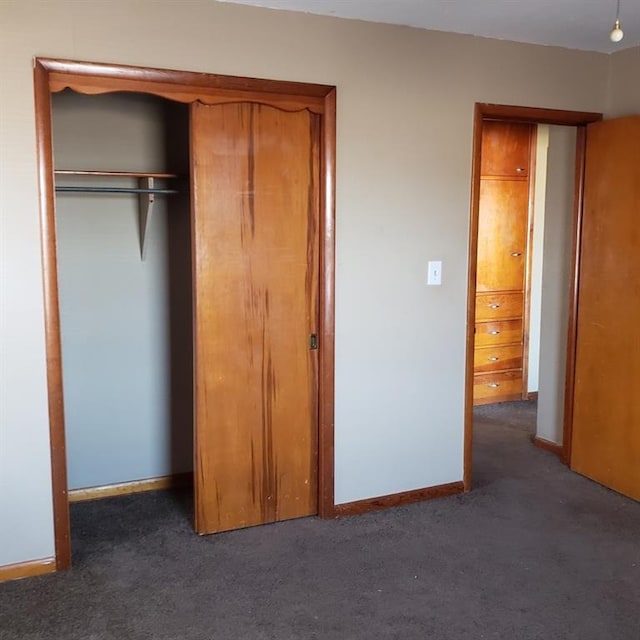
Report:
473,122,534,405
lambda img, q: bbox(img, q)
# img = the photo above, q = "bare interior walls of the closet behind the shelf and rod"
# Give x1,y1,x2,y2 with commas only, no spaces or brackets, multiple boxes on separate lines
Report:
52,91,193,490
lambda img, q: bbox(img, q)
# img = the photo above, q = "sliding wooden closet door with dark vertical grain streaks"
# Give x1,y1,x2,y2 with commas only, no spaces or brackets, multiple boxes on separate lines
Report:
191,103,320,533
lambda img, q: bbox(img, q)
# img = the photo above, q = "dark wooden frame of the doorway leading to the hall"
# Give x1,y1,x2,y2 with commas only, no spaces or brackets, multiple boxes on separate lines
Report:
463,102,602,491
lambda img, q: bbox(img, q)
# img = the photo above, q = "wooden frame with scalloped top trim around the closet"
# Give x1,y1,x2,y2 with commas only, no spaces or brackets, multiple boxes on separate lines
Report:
34,58,336,570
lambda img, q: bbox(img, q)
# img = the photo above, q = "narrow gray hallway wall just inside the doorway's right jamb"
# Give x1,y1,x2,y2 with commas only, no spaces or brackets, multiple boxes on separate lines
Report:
536,126,576,444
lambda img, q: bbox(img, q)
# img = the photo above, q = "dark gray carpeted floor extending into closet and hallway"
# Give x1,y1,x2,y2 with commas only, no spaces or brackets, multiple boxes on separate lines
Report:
0,403,640,640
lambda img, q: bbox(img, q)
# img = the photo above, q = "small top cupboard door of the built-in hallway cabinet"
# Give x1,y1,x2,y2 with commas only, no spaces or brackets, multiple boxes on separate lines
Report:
480,122,531,178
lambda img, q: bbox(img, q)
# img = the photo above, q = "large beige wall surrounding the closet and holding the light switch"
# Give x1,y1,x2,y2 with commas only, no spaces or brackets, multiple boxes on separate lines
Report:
0,0,624,564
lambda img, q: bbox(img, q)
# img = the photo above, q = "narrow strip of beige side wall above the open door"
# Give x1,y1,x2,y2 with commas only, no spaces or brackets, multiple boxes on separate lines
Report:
606,47,640,118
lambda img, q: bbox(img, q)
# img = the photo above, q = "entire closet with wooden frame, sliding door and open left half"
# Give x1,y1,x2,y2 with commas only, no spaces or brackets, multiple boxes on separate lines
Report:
34,58,336,569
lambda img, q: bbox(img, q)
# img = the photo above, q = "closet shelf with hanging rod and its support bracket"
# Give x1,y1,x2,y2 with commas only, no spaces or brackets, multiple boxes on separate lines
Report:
54,169,180,260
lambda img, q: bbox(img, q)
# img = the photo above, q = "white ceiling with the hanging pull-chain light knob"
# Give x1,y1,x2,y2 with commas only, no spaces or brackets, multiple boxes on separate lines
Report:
220,0,640,53
